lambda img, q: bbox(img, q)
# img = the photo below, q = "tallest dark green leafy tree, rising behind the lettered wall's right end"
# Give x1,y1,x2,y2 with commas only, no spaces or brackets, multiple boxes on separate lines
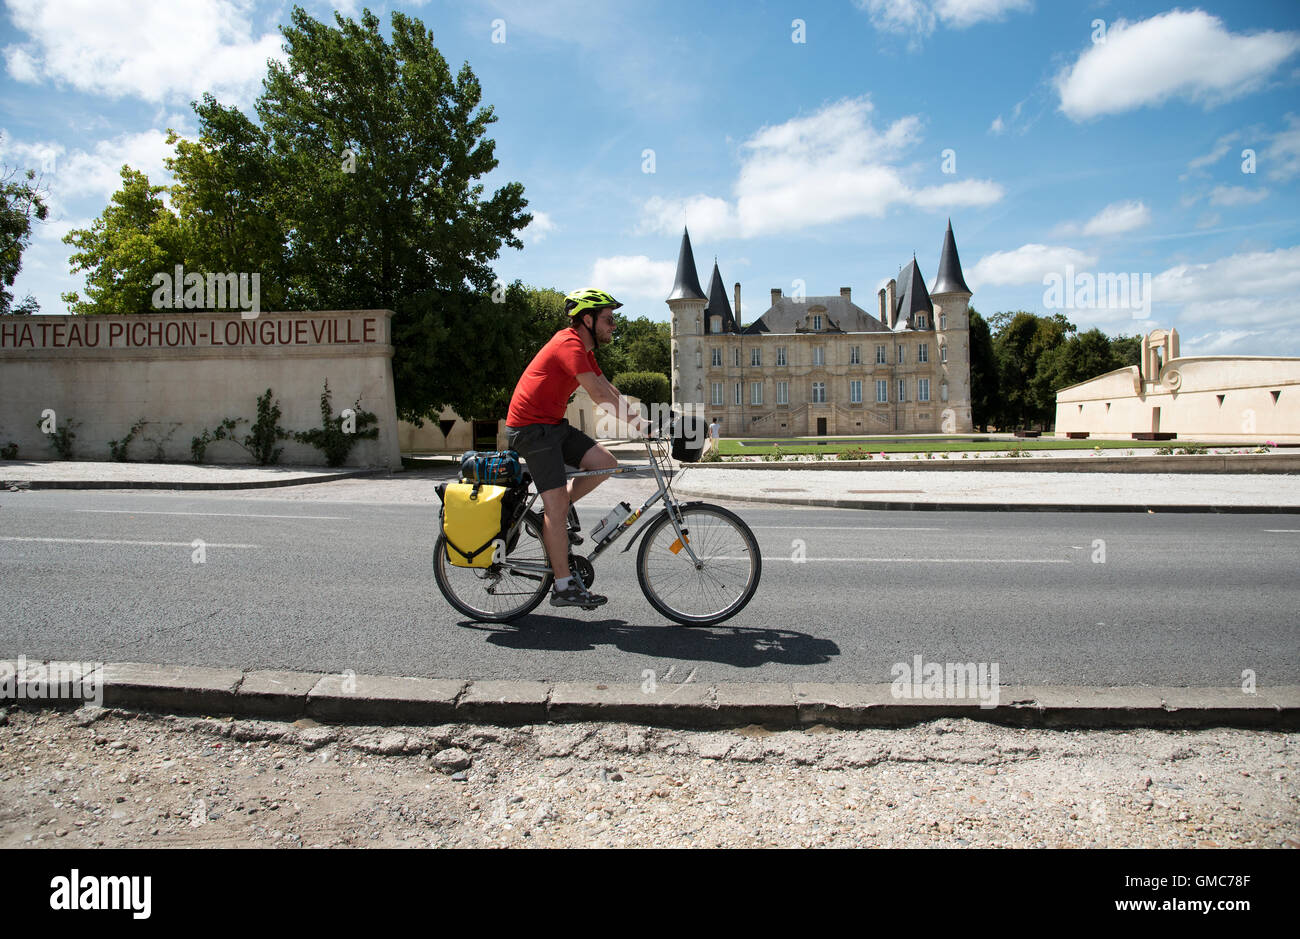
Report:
257,8,532,416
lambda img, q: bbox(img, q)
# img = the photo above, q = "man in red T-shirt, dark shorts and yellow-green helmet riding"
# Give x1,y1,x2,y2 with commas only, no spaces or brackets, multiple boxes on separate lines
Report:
506,287,650,606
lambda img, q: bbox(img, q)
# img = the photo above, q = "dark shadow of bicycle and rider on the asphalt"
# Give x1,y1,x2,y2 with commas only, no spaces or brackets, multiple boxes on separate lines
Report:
458,614,840,668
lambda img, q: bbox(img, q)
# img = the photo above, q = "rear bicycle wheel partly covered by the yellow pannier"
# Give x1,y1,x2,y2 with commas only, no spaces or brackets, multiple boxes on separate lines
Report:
433,523,553,623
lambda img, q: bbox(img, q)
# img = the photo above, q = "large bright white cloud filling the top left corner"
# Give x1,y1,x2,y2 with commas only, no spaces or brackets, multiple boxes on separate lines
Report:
4,0,283,104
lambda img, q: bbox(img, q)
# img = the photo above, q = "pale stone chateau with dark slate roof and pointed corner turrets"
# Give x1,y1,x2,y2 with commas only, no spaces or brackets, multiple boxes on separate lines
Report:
667,221,972,437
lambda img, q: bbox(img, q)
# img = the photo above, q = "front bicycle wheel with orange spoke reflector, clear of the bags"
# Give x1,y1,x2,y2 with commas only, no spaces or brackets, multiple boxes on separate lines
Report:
637,503,763,626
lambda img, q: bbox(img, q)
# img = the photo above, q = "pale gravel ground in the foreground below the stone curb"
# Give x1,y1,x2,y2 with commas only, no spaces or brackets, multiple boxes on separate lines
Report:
0,708,1300,848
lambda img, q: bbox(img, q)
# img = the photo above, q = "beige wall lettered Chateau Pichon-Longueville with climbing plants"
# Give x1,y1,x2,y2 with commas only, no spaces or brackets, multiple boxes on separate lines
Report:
0,310,402,468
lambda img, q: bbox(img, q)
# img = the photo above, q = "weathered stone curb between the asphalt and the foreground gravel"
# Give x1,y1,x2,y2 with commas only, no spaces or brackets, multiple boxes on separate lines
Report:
0,659,1300,730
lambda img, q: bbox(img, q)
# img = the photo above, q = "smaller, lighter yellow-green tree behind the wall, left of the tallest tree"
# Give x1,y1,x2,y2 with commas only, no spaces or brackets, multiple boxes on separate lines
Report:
62,166,187,313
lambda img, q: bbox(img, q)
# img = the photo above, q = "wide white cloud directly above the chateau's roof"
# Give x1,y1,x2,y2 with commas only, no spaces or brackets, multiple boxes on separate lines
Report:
638,96,1004,238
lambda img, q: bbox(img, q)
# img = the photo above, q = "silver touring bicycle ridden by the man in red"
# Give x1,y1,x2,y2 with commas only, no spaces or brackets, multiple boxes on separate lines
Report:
433,437,763,626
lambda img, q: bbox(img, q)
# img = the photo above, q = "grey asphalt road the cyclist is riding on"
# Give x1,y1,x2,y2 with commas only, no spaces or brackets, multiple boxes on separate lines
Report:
0,480,1300,687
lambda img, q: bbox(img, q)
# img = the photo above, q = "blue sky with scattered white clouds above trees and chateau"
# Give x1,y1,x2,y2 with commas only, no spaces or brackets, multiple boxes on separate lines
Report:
0,0,1300,355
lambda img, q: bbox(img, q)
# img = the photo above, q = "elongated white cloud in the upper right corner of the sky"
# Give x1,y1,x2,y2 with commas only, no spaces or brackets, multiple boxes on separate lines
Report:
1056,10,1300,121
